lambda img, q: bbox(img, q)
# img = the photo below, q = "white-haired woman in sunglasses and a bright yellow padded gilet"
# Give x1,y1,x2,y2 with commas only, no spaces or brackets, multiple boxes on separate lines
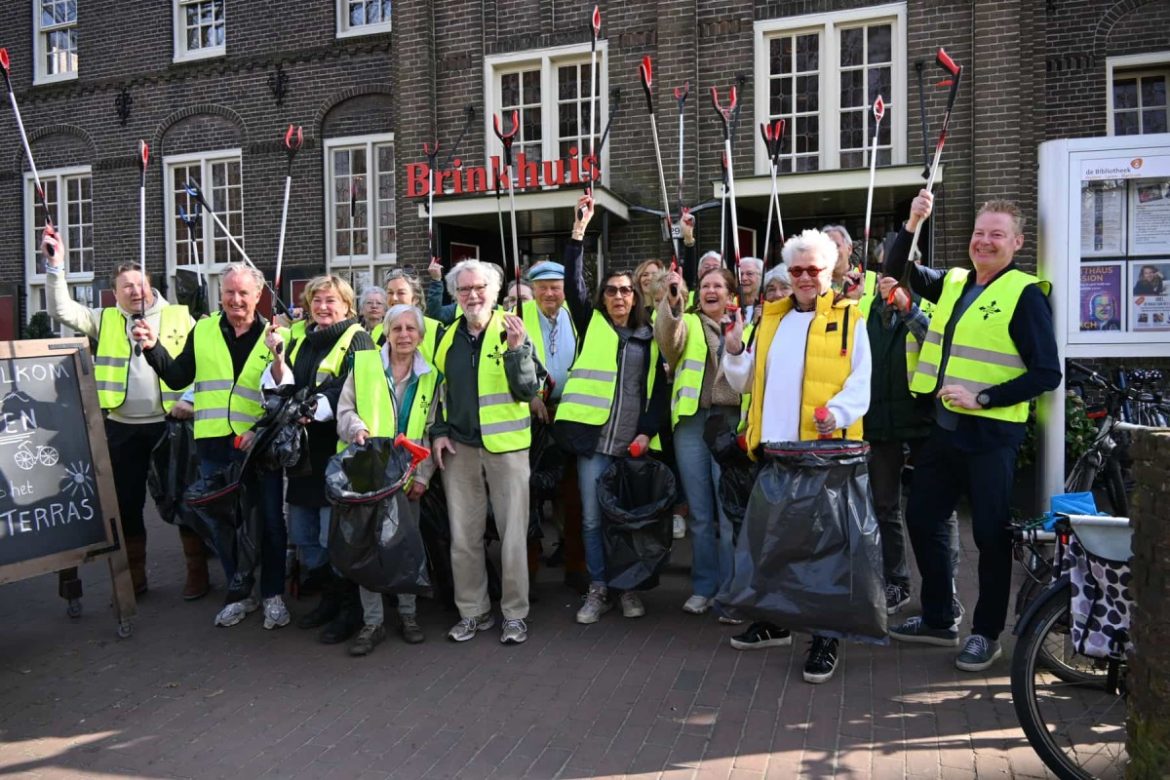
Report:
722,230,870,683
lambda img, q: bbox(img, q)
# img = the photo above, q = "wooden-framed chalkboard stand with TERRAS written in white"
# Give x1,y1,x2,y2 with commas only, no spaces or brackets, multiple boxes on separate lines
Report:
0,339,137,639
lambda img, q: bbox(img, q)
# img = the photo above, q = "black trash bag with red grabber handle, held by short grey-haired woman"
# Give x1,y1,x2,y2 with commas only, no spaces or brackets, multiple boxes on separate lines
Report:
325,439,431,594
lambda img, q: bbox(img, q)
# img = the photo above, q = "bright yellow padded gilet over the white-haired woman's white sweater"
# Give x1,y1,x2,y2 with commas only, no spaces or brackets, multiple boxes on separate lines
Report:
746,292,863,457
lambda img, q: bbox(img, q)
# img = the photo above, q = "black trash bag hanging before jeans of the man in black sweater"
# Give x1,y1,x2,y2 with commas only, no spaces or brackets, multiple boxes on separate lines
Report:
183,462,263,602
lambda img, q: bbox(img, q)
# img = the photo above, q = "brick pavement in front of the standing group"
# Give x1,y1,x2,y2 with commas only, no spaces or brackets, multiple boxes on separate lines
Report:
0,509,1062,780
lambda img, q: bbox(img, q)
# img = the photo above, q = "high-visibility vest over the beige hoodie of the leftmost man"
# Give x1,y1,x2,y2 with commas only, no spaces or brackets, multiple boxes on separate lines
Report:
94,304,191,412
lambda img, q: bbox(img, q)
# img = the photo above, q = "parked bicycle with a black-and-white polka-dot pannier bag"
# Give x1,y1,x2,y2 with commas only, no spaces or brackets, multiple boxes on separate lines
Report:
1011,516,1130,780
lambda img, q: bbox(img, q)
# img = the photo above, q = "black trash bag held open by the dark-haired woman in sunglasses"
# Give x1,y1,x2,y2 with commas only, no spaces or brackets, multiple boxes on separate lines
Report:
597,457,674,591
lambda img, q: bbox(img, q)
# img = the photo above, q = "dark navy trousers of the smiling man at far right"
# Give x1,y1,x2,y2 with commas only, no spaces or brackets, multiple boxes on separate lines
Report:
906,427,1018,640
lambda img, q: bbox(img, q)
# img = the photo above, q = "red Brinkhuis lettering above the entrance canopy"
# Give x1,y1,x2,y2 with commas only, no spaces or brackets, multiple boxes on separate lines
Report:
406,146,601,198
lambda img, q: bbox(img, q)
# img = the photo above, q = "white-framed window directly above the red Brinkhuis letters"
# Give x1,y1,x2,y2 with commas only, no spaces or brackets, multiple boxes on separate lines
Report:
483,41,610,184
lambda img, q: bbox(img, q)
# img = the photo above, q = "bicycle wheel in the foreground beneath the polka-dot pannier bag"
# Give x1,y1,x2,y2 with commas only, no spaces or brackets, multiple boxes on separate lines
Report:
1012,585,1127,780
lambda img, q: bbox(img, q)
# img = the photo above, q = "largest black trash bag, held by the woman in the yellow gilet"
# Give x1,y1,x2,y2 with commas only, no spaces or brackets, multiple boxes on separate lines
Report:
716,439,888,644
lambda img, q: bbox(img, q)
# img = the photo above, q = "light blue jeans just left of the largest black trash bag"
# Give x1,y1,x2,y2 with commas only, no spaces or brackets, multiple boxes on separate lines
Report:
674,408,738,599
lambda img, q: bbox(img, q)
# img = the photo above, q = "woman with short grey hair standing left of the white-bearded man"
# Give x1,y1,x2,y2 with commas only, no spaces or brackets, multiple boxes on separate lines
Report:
337,303,442,656
